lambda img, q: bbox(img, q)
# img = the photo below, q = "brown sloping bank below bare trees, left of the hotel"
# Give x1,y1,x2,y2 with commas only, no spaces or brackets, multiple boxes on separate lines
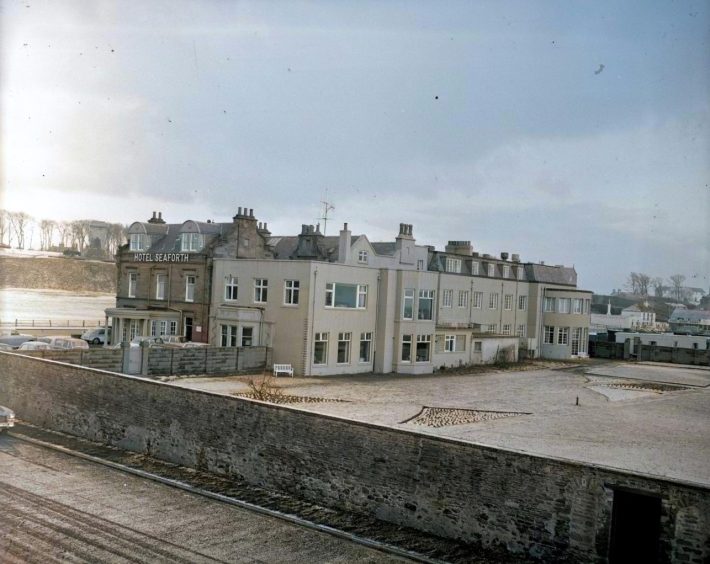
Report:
0,256,116,293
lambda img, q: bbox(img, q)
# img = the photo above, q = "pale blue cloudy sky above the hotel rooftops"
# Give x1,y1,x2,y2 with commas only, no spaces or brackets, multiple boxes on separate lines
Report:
0,0,710,293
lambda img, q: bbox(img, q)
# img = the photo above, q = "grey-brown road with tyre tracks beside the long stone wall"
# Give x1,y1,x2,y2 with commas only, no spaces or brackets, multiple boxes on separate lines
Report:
0,434,403,563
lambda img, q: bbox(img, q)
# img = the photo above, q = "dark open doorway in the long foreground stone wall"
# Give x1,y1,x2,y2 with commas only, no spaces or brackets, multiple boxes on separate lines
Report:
609,490,661,564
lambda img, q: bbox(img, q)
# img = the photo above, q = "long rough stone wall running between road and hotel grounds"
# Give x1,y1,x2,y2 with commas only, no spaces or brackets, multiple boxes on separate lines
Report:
0,353,710,562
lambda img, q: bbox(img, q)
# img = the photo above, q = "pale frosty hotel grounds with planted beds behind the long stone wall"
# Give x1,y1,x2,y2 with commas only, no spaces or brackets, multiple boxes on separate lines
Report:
171,362,710,485
